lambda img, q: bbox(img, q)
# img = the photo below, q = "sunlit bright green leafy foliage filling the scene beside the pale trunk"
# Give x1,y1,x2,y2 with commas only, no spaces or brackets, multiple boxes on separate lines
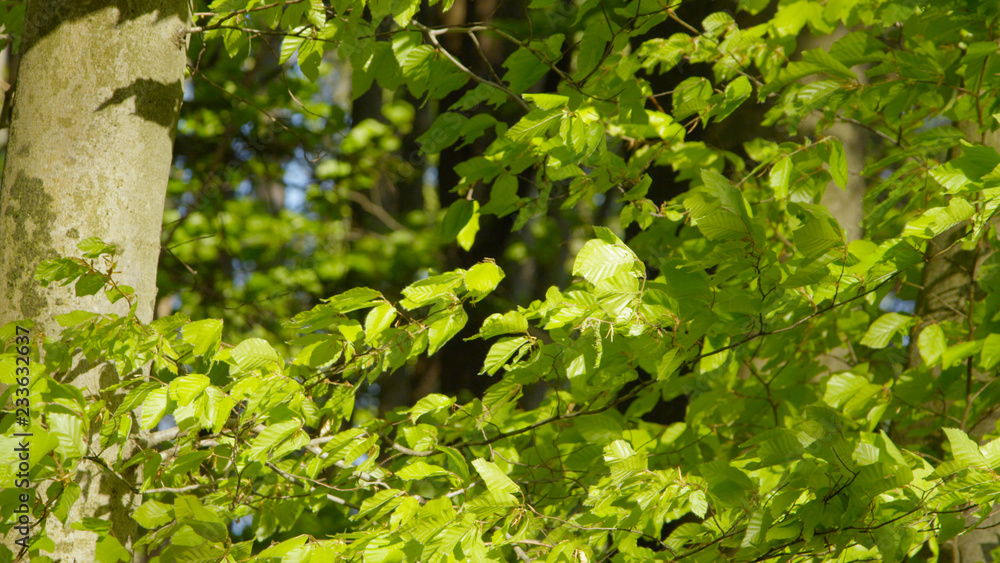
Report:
0,0,1000,563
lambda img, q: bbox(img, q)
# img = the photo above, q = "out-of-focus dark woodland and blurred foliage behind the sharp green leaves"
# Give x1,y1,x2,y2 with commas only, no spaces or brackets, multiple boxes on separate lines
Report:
157,0,752,408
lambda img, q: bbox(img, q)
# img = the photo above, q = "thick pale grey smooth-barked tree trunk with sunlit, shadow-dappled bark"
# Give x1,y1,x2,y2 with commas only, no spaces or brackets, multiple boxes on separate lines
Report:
0,0,190,563
